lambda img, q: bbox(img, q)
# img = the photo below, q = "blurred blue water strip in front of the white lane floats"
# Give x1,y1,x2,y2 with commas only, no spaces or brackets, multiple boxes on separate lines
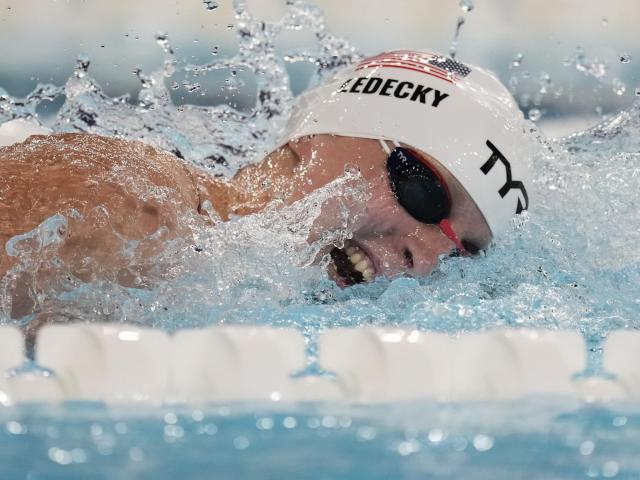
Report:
0,400,640,480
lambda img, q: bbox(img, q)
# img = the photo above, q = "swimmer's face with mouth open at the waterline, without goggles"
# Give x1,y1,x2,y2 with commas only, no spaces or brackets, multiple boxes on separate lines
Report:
278,135,491,285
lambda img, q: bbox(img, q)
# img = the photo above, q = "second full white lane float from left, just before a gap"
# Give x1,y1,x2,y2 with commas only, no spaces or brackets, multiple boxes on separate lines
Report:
171,326,306,402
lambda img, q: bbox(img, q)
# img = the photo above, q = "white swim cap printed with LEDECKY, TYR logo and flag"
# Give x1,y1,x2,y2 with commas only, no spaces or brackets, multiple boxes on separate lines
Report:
282,50,531,237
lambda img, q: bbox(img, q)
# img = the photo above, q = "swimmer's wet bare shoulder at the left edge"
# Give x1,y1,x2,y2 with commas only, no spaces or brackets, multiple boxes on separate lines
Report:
0,133,199,275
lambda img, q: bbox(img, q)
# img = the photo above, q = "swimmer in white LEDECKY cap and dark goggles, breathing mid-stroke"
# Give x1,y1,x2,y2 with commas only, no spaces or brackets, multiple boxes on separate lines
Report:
0,51,531,296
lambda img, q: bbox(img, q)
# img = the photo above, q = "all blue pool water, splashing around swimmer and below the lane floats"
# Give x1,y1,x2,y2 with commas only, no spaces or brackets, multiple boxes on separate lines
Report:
0,1,640,479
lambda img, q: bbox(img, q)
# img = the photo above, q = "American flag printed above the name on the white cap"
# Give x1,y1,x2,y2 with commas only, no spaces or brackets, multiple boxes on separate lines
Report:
356,50,471,83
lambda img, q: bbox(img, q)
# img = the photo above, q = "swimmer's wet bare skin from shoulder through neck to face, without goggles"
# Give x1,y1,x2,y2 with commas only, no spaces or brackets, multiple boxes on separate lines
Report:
0,134,491,290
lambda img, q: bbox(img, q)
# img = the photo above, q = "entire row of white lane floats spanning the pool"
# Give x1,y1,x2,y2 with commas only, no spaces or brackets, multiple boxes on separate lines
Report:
0,324,640,404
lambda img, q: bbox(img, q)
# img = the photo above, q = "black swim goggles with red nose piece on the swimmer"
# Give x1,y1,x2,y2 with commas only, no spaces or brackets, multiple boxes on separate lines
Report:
380,140,468,254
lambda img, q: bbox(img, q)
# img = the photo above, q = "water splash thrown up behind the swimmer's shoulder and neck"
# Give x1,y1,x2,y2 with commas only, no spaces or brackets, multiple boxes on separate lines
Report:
0,0,361,175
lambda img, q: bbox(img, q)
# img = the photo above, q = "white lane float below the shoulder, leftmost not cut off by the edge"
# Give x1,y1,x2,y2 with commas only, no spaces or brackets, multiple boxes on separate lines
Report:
36,324,171,402
